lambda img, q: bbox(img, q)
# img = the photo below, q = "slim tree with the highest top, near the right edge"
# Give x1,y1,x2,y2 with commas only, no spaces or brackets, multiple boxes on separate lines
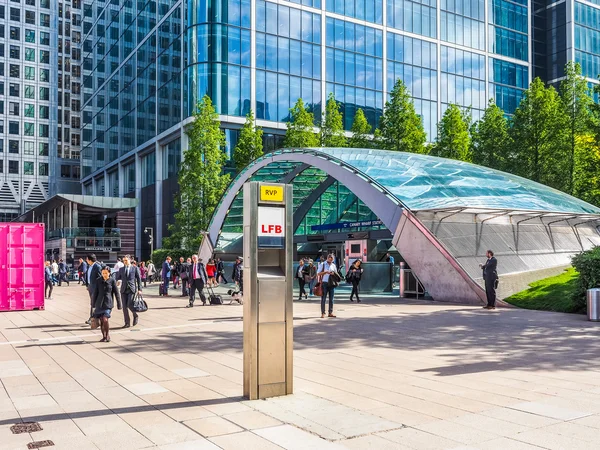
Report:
560,61,593,194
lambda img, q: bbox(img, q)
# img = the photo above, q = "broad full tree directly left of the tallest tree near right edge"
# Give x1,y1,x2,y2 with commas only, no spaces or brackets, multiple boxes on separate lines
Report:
510,78,569,190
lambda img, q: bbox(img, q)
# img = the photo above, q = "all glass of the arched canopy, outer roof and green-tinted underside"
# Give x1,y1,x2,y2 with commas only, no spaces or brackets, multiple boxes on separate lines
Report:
211,148,600,249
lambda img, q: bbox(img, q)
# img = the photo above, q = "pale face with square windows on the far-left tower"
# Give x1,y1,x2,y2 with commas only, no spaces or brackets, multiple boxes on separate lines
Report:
0,0,57,221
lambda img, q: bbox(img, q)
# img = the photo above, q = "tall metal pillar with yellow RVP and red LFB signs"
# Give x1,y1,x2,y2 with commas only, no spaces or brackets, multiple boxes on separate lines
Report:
243,182,294,400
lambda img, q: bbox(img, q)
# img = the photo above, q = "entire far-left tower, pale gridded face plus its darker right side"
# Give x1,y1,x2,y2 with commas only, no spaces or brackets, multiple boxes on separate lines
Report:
0,0,81,221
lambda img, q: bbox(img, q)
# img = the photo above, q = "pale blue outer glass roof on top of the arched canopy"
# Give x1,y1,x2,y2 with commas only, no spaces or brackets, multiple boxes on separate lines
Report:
308,148,600,214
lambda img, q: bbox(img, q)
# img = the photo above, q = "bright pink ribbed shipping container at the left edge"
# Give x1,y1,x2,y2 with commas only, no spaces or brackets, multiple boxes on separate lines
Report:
0,223,44,311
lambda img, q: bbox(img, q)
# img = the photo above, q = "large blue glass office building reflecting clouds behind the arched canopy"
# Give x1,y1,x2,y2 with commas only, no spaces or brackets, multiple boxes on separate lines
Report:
81,0,532,254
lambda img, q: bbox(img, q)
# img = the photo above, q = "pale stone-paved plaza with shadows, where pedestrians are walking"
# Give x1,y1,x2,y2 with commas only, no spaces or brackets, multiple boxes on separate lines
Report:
0,284,600,450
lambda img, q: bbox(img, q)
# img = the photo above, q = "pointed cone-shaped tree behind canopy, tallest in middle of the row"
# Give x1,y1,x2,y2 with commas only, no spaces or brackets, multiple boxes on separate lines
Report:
377,78,427,153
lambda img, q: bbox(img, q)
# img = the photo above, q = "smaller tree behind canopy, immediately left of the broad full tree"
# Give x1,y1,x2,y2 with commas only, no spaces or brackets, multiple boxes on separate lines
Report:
472,100,510,170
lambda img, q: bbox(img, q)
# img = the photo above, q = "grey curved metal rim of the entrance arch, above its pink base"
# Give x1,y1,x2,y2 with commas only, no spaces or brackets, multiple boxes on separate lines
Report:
203,149,404,252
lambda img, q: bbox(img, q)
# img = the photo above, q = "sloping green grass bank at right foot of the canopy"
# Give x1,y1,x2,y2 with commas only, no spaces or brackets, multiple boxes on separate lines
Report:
504,268,578,313
